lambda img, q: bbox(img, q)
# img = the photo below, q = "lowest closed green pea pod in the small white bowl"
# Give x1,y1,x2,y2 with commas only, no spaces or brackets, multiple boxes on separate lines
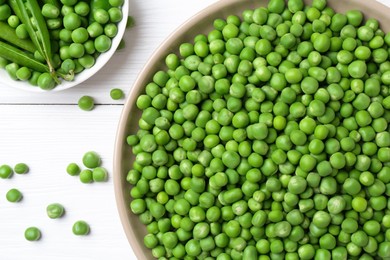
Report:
0,42,49,72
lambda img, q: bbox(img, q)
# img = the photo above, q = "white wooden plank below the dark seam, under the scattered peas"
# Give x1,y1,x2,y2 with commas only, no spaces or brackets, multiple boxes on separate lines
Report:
0,105,135,260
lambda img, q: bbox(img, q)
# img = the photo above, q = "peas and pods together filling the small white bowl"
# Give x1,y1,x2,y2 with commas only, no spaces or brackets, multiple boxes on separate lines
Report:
0,0,123,90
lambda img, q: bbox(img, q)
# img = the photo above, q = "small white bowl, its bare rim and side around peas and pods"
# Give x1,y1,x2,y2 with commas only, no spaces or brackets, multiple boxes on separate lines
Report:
0,0,129,92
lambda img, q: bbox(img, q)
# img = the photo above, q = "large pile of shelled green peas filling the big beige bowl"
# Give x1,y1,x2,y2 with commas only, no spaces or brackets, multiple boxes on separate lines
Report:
127,0,390,260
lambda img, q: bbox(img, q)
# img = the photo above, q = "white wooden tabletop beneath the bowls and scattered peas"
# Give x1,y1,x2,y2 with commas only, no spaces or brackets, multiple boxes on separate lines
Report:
0,0,390,260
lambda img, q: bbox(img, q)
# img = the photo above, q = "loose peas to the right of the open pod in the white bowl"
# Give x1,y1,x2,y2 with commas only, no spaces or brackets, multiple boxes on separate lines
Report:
56,0,123,72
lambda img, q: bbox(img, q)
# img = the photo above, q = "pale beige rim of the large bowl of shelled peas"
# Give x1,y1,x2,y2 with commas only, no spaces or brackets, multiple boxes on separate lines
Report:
113,0,390,259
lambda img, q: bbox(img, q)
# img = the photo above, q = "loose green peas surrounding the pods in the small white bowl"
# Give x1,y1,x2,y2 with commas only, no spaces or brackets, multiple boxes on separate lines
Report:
0,0,124,90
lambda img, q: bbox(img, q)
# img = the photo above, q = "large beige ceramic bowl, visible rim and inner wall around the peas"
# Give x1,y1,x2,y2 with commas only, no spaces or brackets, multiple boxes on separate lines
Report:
114,0,390,260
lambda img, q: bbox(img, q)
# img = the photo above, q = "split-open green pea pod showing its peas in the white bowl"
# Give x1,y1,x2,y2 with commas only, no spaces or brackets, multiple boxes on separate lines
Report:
9,0,55,74
